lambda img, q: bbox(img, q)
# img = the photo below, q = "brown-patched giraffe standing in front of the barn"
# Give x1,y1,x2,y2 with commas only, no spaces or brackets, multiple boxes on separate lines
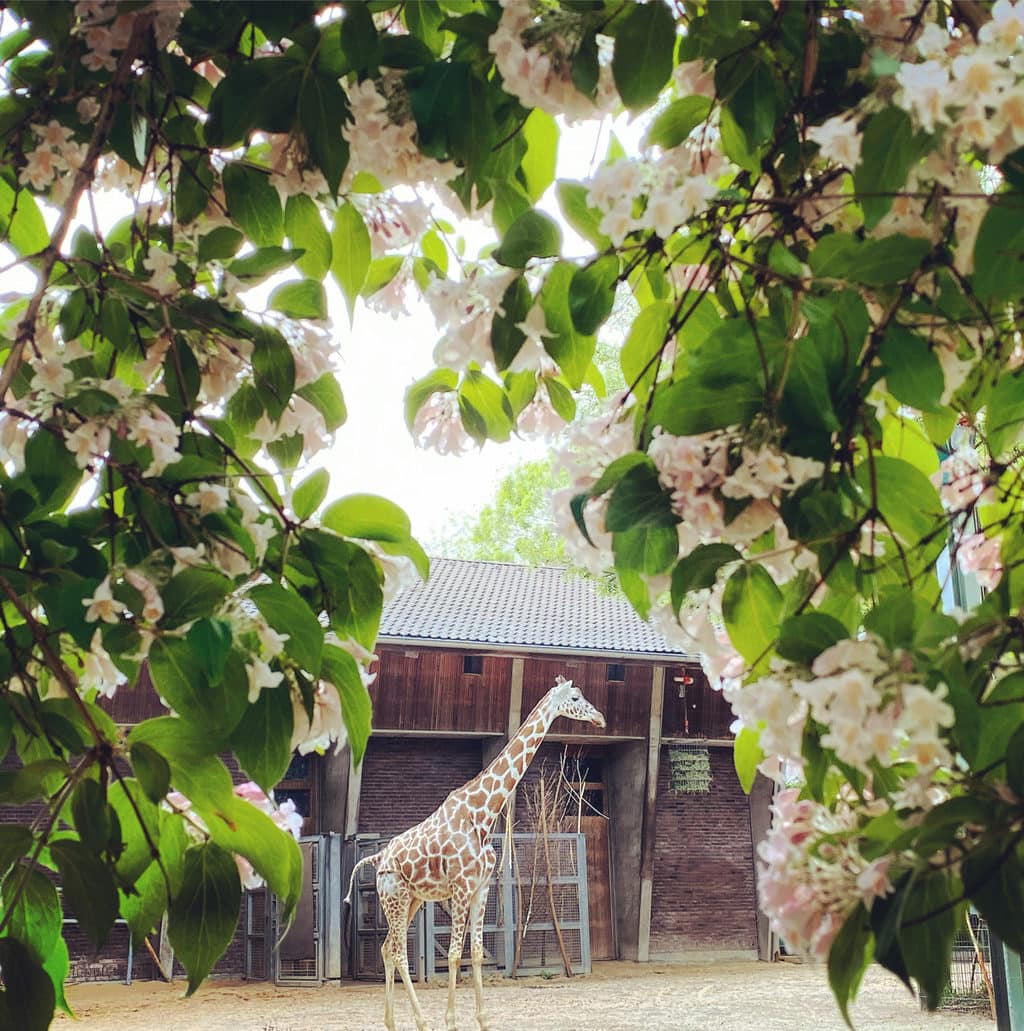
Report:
344,676,604,1031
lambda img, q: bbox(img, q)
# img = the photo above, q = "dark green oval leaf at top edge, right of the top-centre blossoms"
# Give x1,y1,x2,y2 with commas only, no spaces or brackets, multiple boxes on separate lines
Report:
612,0,675,111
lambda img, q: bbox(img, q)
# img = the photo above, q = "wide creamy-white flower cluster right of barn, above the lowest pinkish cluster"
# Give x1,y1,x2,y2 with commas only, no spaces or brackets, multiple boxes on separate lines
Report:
725,636,954,776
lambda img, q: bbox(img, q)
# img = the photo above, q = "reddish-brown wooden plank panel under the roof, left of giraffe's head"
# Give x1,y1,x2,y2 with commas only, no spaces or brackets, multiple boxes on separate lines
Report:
370,646,511,734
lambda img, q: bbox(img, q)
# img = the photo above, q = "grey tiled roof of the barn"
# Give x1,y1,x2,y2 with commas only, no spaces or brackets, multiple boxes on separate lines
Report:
379,559,697,658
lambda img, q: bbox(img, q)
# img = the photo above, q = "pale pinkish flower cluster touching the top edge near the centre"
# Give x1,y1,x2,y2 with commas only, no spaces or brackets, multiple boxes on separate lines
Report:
487,0,619,123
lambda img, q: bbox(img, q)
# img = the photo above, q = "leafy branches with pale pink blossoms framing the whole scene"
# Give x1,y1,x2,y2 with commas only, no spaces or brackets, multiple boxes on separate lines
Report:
0,0,1024,1028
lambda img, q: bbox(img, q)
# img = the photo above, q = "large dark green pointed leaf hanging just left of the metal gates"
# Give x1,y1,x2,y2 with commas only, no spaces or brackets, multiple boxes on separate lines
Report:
168,842,241,995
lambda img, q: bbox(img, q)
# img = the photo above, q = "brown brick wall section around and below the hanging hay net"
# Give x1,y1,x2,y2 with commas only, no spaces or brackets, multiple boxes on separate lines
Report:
651,749,757,958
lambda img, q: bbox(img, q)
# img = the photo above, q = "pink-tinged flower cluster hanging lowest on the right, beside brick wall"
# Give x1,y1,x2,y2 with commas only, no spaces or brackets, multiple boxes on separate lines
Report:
757,788,894,960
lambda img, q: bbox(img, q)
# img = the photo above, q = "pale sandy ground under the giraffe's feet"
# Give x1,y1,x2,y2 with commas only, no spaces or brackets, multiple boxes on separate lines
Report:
54,962,995,1031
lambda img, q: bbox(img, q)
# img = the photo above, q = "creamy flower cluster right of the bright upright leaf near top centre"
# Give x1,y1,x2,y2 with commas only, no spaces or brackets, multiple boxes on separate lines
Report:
589,140,723,246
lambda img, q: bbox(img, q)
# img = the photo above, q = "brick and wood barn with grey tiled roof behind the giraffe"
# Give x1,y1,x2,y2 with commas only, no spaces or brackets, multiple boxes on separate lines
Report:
19,559,770,983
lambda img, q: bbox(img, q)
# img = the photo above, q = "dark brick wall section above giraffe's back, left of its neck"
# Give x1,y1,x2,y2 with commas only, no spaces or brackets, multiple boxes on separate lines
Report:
359,734,483,834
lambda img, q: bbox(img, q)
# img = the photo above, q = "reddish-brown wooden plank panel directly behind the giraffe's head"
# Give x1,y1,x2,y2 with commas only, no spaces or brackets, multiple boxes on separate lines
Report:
515,658,652,737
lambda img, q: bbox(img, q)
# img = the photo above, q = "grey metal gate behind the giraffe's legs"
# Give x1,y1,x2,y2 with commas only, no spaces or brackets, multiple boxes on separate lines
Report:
345,834,590,980
